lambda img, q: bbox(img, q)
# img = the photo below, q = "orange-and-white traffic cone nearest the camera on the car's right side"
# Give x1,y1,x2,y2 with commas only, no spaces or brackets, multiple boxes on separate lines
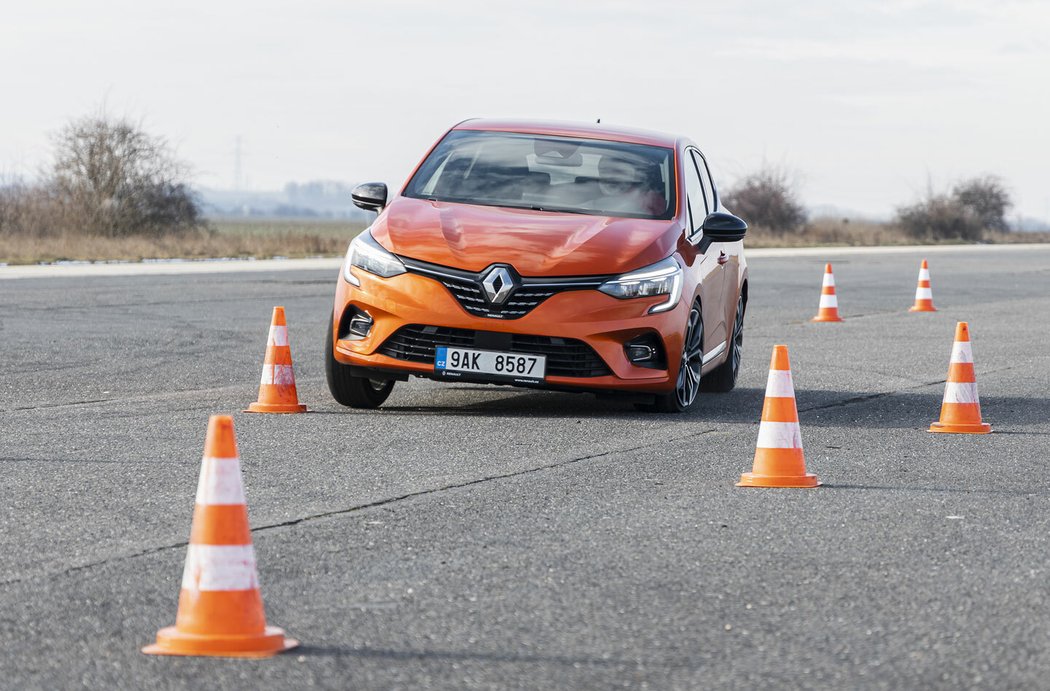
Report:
736,346,820,487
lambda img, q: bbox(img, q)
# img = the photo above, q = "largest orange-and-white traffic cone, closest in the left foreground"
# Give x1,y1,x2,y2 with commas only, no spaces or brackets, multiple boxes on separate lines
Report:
142,415,299,657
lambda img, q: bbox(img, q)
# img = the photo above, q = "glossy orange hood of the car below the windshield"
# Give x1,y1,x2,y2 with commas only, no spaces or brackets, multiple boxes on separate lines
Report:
372,196,681,276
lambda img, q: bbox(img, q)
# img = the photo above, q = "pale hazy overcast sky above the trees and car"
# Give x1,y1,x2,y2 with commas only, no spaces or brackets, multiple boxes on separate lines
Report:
0,0,1050,221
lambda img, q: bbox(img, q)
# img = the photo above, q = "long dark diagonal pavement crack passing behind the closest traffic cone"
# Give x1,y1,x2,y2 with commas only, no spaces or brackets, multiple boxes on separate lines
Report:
0,428,716,588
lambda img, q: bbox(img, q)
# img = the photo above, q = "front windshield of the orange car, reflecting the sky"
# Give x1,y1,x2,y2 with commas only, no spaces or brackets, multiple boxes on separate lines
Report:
404,130,675,219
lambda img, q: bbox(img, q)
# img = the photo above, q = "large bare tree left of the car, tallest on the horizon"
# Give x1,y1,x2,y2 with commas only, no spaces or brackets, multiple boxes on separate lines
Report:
50,113,202,236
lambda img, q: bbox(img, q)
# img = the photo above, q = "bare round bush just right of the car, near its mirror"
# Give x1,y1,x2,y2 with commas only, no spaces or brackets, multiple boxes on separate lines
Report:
722,166,806,234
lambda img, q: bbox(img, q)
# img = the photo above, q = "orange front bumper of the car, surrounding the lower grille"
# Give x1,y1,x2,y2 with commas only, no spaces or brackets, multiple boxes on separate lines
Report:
333,264,689,393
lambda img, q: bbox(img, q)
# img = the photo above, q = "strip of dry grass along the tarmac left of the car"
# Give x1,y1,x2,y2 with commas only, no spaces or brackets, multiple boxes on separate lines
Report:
0,219,363,264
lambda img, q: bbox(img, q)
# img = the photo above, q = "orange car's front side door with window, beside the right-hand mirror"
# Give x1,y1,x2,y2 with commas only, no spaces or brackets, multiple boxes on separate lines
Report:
683,149,726,354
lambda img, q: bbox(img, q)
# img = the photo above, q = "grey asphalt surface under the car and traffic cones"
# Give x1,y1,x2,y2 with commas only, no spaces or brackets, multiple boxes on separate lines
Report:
0,247,1050,689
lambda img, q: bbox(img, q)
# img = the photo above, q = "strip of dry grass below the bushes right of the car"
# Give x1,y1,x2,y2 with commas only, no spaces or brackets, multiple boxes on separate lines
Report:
744,218,1050,248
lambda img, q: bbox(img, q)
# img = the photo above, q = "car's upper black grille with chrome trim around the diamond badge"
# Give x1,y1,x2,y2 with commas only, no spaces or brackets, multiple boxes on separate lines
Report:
400,257,609,319
